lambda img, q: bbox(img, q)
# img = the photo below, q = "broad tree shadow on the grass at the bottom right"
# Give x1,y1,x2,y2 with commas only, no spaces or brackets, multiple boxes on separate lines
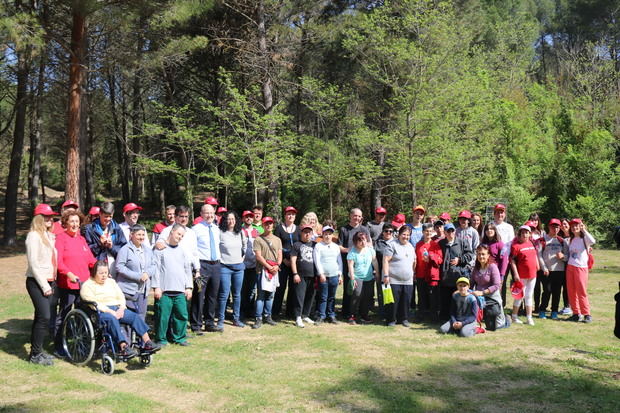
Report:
315,354,620,413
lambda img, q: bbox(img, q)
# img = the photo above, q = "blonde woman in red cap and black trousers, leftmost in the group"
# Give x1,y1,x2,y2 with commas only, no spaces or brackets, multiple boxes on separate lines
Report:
26,204,57,366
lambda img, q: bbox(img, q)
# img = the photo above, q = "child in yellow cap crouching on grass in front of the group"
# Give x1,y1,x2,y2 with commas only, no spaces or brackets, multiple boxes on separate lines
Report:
439,277,478,337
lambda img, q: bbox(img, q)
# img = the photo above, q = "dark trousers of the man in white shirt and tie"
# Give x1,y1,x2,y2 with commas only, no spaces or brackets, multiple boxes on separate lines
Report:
190,260,221,331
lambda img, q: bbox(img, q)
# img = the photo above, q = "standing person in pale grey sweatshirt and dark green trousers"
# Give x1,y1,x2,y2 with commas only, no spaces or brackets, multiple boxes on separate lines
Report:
151,224,193,346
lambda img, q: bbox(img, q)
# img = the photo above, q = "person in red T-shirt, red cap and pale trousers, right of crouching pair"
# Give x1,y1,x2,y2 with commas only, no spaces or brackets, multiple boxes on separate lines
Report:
510,225,540,326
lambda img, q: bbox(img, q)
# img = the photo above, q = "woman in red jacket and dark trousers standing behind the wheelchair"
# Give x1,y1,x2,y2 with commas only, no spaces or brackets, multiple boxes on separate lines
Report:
54,211,96,357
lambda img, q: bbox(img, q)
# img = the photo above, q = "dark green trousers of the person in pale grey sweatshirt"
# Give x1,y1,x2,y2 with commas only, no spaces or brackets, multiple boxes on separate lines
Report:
155,294,188,343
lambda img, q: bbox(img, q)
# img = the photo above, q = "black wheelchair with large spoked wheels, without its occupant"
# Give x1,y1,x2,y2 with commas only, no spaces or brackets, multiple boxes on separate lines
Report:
62,300,157,375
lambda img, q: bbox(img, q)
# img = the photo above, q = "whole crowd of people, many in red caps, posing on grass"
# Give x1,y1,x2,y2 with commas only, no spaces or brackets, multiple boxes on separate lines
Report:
26,197,595,365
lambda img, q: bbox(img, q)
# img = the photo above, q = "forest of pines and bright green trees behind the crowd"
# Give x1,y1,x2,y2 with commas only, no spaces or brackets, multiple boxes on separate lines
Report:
0,0,620,245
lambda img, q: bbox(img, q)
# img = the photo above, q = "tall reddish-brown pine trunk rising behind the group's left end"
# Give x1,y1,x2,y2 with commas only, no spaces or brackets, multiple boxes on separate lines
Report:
65,5,86,200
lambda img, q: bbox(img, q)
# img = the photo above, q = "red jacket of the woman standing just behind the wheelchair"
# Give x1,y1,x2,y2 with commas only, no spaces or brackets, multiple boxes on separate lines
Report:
56,231,97,290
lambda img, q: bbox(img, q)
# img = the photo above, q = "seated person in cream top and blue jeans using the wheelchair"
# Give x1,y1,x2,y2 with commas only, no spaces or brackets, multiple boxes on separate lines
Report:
80,260,159,357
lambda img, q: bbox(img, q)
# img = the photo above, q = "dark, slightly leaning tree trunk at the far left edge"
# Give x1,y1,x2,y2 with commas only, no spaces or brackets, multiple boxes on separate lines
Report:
3,47,30,246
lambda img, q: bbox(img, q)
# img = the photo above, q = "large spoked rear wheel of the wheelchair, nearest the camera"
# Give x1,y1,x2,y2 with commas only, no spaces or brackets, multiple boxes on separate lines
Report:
62,308,95,366
